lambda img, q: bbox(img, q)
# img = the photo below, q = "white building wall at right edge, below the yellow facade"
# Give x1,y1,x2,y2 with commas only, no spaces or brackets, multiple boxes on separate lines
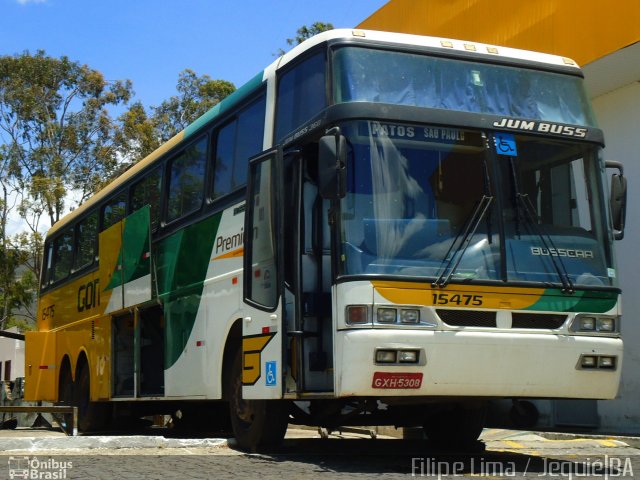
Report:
587,80,640,433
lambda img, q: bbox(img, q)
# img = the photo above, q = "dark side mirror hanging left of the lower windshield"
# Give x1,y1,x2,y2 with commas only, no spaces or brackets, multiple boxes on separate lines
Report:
318,128,347,200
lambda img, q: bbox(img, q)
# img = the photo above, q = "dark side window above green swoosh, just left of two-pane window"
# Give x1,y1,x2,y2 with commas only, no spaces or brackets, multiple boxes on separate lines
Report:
167,137,207,222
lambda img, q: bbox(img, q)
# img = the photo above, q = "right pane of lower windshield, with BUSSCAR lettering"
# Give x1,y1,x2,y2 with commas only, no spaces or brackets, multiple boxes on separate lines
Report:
496,134,614,286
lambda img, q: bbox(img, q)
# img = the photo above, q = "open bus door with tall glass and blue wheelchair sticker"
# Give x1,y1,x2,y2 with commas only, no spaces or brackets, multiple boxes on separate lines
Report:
242,149,285,399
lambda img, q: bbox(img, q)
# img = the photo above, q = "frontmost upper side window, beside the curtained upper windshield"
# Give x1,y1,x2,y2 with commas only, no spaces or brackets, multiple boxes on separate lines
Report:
275,52,327,141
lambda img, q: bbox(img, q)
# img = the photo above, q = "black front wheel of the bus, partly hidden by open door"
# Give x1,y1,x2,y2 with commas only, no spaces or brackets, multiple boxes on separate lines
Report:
227,351,289,451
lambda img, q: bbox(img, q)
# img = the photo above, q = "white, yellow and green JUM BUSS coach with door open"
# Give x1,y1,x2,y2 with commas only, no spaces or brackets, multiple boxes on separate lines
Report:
26,30,626,449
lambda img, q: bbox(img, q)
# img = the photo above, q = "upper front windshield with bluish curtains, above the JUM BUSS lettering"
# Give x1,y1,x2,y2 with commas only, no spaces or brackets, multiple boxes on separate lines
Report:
333,47,595,126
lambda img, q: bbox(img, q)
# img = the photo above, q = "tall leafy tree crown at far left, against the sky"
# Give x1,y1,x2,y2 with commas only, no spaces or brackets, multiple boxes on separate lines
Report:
0,50,132,225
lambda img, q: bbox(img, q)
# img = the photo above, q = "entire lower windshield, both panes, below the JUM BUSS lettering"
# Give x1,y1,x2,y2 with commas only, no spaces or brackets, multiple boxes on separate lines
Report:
340,121,615,286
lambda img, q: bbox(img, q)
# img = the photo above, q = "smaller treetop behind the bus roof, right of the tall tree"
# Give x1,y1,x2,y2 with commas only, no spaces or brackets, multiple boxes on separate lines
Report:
118,69,236,165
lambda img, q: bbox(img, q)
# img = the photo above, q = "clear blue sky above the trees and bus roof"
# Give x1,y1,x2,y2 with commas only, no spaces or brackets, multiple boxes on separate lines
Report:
0,0,387,107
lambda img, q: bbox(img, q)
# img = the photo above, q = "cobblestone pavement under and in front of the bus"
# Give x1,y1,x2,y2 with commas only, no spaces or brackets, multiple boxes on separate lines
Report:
0,429,640,480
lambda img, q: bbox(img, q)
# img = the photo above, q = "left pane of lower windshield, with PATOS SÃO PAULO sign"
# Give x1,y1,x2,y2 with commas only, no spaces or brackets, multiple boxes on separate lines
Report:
341,122,500,279
